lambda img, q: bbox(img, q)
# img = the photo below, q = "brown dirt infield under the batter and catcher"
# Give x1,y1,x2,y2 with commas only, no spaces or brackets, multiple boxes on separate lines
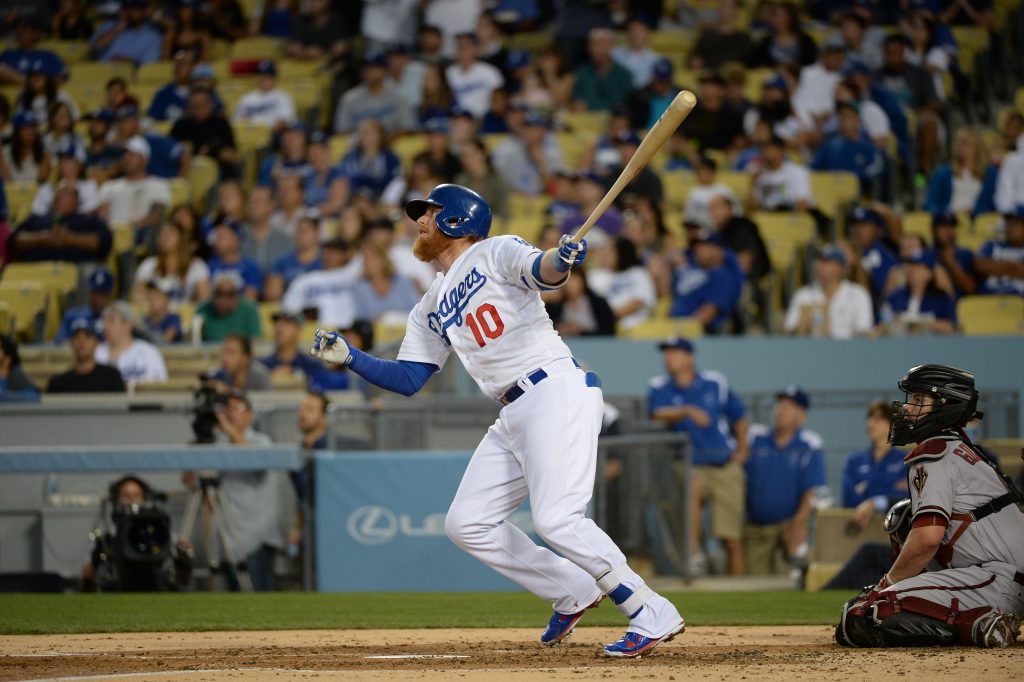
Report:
0,626,1024,682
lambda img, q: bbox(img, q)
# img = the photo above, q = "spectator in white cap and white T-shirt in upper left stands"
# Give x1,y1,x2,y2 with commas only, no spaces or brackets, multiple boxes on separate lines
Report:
97,135,171,244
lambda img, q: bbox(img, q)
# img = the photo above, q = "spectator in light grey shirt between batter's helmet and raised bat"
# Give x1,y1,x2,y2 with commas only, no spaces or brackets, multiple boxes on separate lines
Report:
492,112,565,196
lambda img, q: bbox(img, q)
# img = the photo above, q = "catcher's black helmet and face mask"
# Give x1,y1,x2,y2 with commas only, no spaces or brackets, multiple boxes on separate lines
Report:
889,365,981,445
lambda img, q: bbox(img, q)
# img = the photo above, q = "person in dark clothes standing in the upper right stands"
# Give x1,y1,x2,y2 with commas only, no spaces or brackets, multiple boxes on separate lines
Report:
876,35,939,174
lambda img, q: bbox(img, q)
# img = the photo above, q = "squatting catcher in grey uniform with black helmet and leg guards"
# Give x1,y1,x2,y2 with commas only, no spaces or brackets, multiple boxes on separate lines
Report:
836,365,1024,647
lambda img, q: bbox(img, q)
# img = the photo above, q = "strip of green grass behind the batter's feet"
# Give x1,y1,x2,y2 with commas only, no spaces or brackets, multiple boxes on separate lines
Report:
0,592,851,635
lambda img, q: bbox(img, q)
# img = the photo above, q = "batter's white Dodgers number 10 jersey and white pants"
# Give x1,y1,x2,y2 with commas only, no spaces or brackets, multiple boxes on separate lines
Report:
398,237,682,637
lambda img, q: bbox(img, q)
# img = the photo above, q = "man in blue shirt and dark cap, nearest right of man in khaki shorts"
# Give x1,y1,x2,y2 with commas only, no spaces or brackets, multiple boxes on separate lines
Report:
743,386,827,574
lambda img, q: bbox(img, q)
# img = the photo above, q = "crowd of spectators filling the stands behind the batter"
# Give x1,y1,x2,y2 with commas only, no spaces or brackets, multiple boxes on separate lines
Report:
0,0,1024,393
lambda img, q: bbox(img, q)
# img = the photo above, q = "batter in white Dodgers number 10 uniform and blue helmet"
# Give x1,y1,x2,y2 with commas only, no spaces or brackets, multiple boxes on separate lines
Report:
311,184,684,657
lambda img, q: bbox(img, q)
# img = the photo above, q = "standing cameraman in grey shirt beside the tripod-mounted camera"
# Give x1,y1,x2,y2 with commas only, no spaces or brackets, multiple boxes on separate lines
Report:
215,391,297,592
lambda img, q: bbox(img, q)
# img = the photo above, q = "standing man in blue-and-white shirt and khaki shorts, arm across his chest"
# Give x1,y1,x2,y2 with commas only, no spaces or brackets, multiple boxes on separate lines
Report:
647,338,748,576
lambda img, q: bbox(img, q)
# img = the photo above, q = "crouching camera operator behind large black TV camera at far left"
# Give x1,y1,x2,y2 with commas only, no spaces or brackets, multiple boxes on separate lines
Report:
82,475,191,592
